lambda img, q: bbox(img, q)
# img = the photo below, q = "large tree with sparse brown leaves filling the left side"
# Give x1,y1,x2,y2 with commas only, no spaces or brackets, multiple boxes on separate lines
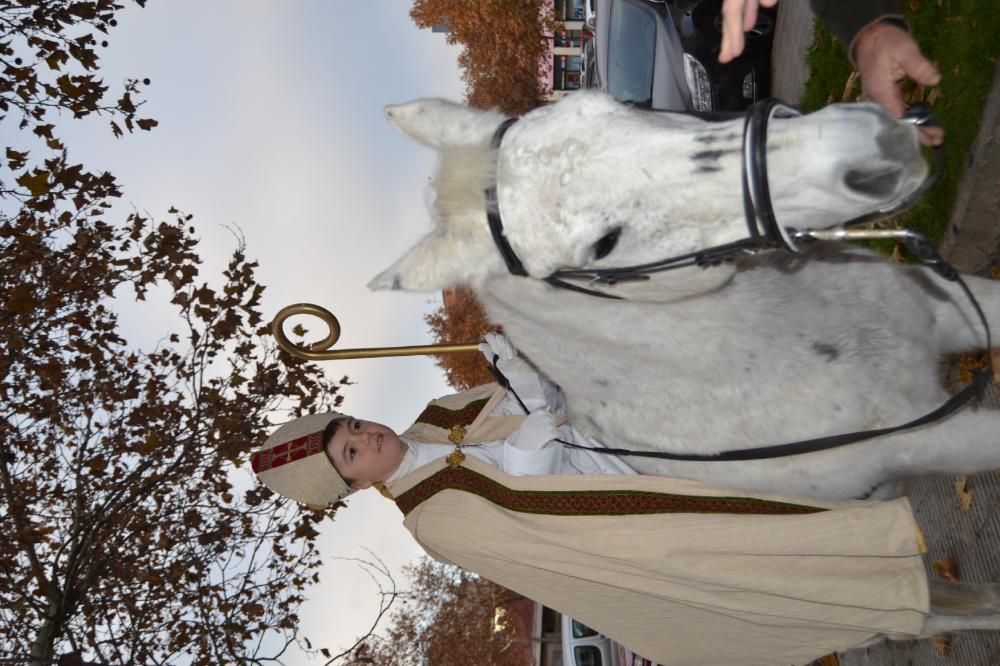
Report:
0,0,374,664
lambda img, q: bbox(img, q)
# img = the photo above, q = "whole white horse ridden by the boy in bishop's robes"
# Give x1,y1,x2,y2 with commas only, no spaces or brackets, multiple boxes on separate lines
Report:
369,93,1000,499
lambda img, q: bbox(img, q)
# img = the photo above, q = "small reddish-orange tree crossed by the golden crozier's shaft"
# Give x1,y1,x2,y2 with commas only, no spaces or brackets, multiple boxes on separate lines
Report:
424,286,500,390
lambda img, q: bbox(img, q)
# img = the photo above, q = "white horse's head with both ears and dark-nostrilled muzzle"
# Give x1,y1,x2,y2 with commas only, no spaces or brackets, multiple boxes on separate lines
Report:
370,92,927,290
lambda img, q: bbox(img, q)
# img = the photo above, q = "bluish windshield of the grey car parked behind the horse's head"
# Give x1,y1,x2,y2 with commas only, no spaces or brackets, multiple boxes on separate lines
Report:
608,0,656,106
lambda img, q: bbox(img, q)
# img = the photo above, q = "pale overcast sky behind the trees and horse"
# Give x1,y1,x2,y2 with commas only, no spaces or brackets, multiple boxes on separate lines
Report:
55,0,472,664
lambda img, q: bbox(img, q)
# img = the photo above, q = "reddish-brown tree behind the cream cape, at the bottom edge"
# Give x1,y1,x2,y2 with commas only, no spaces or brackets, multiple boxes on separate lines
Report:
367,557,522,666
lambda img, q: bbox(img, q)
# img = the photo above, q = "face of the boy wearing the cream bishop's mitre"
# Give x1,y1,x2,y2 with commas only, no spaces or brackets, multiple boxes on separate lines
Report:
326,418,406,490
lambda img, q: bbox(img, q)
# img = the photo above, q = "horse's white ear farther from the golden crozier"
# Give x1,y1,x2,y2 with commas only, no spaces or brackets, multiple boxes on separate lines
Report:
385,99,504,148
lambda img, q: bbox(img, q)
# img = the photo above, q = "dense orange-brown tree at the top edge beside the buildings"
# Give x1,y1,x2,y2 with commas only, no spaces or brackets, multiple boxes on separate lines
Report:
410,0,556,115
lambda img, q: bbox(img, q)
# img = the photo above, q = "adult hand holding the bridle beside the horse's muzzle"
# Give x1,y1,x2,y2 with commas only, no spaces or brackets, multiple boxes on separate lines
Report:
854,23,944,146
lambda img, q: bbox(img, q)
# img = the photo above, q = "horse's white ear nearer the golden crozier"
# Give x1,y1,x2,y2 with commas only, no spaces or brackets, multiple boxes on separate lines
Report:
368,231,498,291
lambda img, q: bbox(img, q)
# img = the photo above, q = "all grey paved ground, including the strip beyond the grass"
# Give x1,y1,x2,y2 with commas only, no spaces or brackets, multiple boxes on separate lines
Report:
773,0,1000,666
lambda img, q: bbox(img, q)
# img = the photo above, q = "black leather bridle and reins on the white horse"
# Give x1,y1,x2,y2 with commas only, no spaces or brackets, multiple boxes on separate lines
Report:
485,99,993,462
